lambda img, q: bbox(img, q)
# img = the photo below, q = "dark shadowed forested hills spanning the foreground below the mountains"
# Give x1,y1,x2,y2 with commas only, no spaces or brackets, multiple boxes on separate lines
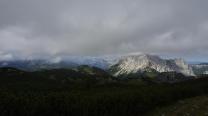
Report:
0,66,208,116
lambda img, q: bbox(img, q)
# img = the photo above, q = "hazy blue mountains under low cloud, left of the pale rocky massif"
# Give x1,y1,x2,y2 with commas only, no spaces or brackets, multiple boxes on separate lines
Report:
0,56,119,71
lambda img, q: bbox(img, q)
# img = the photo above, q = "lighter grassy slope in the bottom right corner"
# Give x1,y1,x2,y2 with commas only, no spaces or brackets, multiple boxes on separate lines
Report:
146,96,208,116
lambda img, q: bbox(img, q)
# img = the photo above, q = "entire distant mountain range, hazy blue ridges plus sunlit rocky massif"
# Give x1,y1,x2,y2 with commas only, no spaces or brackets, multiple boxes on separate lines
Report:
0,54,208,76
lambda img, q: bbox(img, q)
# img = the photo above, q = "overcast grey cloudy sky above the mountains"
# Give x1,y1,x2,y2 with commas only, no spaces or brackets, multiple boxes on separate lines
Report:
0,0,208,61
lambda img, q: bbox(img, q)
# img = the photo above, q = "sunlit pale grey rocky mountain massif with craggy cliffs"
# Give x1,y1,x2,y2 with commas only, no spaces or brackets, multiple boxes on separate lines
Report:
110,54,194,76
